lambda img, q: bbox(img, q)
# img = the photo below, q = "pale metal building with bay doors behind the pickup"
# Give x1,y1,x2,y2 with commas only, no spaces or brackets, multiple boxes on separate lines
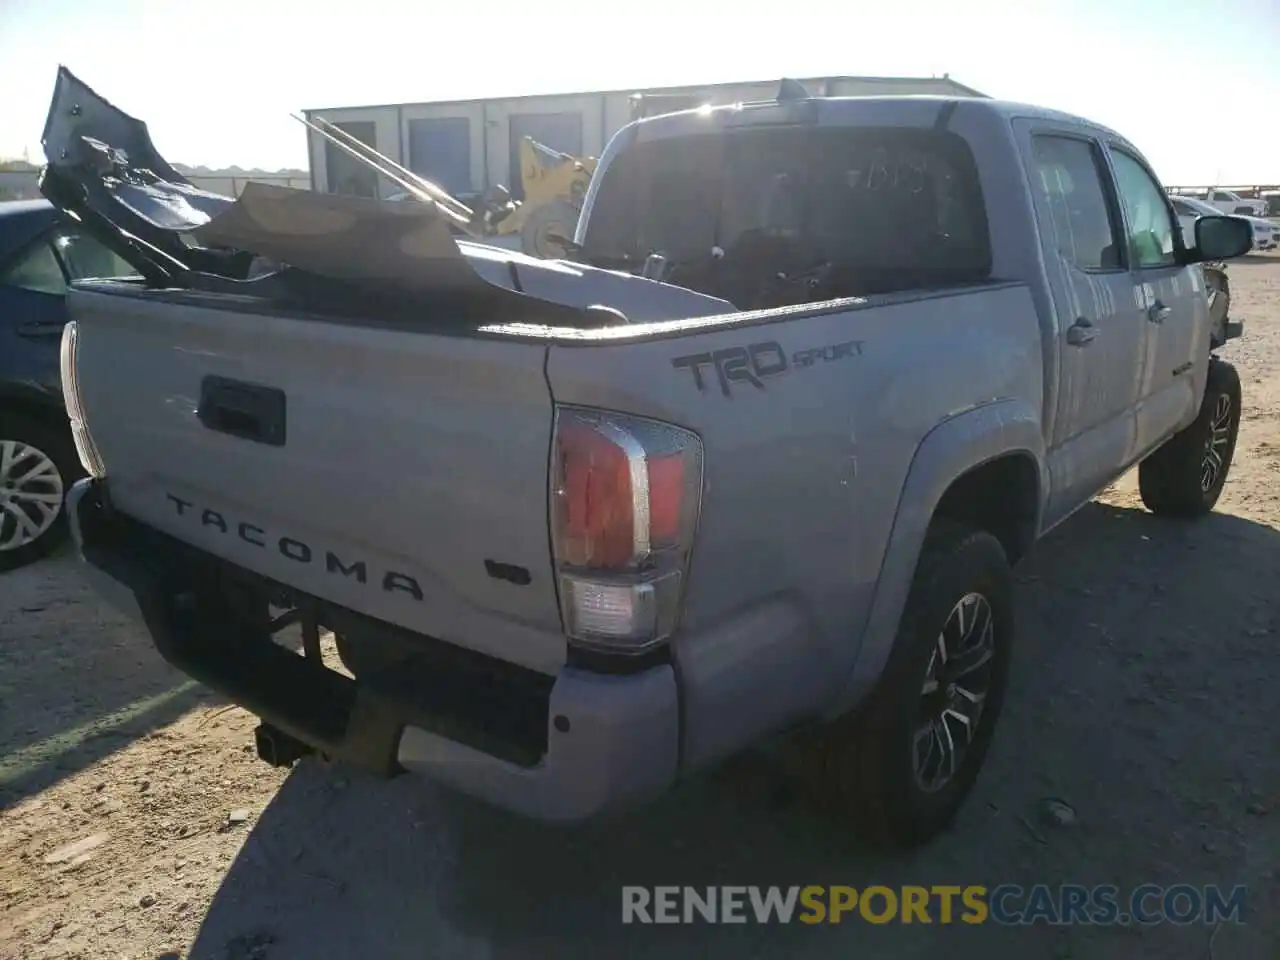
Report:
303,74,984,200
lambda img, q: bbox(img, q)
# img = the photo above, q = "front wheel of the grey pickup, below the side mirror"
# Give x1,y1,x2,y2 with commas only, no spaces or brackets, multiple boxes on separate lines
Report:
1138,357,1240,518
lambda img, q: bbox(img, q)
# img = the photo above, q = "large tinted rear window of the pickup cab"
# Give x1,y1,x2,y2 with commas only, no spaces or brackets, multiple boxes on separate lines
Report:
582,125,991,296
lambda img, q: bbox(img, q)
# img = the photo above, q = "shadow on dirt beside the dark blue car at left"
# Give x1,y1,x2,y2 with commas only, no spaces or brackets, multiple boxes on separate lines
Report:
0,550,216,809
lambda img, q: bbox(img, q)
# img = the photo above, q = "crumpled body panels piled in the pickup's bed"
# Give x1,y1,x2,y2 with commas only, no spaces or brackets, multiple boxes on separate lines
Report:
41,68,733,329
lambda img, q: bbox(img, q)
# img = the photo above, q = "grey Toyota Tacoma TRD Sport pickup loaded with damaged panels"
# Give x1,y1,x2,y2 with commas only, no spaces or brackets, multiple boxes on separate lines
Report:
44,72,1251,845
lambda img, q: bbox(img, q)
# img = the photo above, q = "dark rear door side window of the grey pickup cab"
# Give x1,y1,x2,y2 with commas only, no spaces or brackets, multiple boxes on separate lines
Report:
1032,134,1123,271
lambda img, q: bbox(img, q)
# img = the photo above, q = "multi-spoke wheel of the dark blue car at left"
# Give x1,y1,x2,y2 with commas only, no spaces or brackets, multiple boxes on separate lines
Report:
0,413,83,571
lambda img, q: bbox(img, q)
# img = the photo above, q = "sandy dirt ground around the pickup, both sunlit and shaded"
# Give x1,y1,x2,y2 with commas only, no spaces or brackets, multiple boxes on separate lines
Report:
0,256,1280,960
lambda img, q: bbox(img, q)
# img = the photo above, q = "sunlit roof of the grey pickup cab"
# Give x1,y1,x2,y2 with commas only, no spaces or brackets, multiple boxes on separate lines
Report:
635,95,1128,152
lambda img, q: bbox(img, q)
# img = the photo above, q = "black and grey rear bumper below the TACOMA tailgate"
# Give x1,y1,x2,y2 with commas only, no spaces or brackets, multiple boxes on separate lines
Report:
68,479,680,822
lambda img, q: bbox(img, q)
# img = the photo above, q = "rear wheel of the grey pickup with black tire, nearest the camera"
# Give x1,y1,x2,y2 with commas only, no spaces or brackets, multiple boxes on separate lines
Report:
810,521,1014,847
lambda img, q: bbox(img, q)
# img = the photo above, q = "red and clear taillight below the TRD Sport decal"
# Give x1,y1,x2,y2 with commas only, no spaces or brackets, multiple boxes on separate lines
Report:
552,407,703,653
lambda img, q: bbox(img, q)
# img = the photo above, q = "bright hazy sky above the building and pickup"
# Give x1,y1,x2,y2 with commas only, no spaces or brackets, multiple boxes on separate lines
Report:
0,0,1280,186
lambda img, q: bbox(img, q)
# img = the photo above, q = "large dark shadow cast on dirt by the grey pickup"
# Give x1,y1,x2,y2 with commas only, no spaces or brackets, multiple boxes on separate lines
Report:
175,503,1280,960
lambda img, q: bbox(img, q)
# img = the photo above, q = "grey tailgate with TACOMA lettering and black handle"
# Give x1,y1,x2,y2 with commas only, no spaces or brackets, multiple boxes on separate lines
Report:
70,285,564,673
